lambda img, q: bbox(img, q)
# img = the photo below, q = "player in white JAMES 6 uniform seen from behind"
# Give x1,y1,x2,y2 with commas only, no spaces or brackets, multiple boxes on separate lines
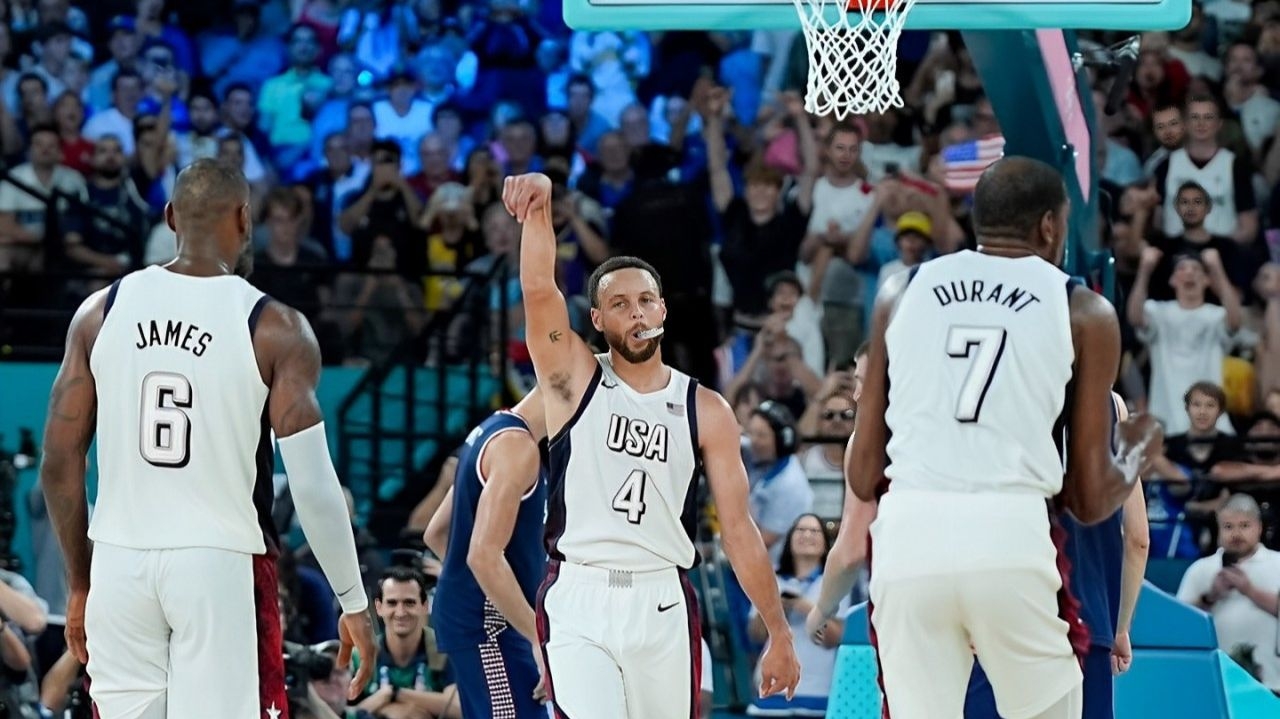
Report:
41,160,376,719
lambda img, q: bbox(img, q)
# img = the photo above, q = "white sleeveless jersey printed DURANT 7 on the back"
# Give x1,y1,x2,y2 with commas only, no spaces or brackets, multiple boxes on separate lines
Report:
884,251,1075,496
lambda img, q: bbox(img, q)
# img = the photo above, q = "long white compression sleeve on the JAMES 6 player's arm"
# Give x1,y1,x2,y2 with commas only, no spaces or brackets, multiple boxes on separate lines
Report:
278,422,369,614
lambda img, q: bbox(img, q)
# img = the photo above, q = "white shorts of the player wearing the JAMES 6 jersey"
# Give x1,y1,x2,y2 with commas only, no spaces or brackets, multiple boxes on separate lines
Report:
84,542,288,719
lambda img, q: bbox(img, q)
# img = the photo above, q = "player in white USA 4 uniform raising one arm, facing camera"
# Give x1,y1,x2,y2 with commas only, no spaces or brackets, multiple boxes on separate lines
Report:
503,174,800,719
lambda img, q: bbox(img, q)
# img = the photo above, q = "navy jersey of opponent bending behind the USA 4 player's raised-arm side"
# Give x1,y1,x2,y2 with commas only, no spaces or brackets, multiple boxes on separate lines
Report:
431,412,547,651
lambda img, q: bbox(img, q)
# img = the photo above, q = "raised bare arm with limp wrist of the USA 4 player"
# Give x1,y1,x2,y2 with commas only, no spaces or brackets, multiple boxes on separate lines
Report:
502,173,595,435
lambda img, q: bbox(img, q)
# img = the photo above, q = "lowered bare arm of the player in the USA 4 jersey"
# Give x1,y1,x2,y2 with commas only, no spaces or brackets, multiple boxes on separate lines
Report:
698,388,800,699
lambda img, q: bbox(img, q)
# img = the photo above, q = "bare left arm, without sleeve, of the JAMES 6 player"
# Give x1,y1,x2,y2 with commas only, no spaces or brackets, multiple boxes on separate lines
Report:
40,290,106,663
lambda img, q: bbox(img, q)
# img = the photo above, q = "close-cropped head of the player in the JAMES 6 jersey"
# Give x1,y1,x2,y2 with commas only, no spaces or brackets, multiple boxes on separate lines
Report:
165,160,253,276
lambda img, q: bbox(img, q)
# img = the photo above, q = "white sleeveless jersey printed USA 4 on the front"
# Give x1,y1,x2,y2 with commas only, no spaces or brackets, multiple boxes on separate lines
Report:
547,354,700,572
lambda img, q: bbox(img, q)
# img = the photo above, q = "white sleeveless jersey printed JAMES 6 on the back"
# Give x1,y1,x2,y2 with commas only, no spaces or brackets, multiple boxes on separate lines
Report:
88,266,274,554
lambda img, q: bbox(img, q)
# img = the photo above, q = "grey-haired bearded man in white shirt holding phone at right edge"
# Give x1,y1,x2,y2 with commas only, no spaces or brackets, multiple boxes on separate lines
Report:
1178,494,1280,691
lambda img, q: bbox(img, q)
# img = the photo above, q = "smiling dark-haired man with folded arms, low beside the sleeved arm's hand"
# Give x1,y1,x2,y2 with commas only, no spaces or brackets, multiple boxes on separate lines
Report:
351,567,462,719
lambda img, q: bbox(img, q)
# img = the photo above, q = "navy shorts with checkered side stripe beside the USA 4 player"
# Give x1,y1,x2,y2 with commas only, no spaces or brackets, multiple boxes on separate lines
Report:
449,627,547,719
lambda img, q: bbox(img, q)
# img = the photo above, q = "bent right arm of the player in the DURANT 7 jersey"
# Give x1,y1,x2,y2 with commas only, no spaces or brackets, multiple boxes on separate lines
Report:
1059,287,1164,525
